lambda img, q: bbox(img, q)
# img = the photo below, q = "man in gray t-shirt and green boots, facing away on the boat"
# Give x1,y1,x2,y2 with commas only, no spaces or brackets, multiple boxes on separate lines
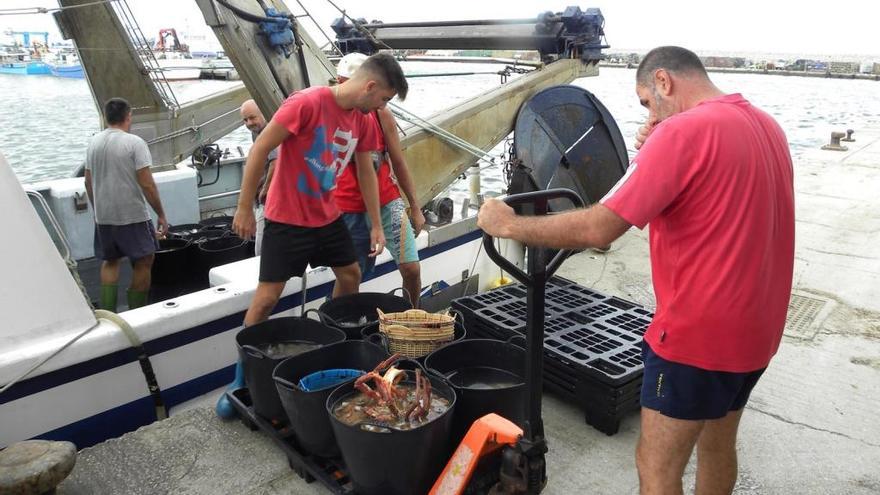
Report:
85,98,168,311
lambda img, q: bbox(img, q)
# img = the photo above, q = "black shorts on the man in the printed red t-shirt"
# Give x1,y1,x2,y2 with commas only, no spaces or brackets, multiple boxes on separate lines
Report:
260,217,357,282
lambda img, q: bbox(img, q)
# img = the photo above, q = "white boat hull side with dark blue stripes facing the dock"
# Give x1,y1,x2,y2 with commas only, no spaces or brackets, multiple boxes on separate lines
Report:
0,225,502,449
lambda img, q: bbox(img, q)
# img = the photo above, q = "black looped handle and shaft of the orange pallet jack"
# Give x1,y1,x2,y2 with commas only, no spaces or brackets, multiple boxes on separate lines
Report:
483,188,584,494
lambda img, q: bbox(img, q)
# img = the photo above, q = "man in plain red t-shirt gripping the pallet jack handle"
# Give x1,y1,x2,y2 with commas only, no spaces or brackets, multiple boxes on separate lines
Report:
479,47,794,493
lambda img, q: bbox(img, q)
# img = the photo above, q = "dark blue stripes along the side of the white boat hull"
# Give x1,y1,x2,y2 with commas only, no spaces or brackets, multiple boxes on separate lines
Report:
0,230,482,449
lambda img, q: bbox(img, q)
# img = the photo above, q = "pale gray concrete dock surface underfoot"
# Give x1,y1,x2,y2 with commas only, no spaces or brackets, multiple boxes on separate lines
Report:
57,129,880,495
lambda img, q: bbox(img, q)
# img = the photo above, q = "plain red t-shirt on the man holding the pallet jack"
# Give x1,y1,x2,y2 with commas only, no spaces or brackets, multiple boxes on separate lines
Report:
601,94,794,372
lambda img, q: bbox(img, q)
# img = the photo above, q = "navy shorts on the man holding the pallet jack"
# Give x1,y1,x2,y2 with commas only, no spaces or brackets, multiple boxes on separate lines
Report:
641,342,766,420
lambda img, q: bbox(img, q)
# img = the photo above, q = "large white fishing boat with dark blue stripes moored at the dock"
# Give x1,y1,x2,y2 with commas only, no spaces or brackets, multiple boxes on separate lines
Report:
0,0,626,454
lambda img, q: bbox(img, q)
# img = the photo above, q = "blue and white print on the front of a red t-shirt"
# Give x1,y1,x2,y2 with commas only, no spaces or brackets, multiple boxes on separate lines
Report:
297,126,358,198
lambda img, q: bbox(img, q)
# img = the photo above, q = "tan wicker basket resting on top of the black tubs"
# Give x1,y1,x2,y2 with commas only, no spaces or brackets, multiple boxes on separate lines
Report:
376,309,455,358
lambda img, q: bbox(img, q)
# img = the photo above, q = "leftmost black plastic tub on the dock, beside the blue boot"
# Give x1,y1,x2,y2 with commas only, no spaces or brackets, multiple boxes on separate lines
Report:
235,316,345,423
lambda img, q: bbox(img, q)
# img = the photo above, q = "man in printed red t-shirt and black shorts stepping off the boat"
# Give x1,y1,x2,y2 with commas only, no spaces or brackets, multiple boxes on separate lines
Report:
216,53,409,418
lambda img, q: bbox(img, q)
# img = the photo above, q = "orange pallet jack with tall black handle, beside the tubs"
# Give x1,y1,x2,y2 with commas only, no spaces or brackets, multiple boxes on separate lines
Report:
430,189,584,495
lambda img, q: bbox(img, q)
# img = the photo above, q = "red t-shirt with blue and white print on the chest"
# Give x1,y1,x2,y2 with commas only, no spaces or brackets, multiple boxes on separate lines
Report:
265,86,379,227
